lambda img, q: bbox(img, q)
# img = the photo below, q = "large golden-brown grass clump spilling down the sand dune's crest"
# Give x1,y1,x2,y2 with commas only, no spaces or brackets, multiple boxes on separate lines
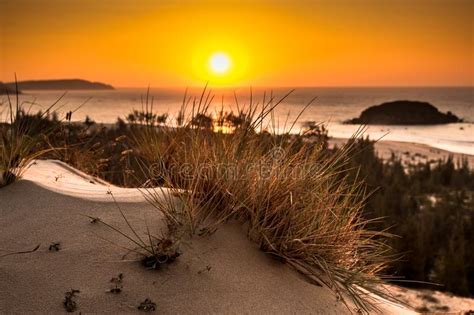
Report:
133,90,398,311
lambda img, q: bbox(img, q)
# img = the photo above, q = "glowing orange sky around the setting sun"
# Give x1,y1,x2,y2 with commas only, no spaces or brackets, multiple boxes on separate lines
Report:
0,0,474,87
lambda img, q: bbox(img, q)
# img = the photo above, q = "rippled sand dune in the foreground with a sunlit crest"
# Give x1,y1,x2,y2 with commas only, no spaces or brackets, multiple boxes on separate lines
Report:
0,161,466,314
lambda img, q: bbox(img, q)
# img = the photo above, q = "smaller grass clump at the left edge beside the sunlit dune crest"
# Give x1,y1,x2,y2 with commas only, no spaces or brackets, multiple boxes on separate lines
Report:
0,82,62,188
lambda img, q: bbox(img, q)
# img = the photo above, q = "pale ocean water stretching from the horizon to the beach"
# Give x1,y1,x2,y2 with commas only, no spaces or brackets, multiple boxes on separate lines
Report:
0,87,474,154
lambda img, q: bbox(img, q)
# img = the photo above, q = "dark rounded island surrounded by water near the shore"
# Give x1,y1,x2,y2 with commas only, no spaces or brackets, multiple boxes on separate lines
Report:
345,100,462,125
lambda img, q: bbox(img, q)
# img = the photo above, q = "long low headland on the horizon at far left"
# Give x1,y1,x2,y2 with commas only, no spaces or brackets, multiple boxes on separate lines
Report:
5,79,114,90
